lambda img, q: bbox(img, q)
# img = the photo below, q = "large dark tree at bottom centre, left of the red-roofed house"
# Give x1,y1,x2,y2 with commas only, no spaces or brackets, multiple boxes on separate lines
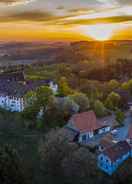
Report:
39,128,78,183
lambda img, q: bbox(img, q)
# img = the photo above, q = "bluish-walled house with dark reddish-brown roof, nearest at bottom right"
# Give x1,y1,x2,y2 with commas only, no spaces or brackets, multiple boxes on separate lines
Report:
98,141,131,175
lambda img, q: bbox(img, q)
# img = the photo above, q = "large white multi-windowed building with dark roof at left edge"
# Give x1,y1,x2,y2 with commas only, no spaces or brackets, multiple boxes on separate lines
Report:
0,72,58,112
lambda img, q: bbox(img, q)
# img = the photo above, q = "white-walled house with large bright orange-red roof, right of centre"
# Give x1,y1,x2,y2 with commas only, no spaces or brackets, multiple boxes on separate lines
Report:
66,111,111,144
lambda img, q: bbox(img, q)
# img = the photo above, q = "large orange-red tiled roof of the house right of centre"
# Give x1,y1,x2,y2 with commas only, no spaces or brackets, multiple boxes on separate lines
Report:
71,111,104,132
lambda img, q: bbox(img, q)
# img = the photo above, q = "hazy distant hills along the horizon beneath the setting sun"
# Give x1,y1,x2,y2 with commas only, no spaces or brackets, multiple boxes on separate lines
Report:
0,40,132,66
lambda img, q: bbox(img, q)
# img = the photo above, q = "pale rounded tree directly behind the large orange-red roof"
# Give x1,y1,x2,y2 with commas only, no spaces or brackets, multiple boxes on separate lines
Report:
70,93,90,111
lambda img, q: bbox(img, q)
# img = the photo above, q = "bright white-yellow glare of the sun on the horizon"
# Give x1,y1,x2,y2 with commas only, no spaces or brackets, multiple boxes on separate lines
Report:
80,24,117,41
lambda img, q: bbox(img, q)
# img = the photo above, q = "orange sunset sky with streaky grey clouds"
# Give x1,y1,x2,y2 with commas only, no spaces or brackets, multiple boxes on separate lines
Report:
0,0,132,41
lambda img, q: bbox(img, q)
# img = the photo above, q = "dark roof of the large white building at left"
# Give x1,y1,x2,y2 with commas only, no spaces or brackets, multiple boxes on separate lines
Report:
0,71,56,97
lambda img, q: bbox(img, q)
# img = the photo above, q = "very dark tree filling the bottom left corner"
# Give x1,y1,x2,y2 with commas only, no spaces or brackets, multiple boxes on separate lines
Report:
0,145,29,184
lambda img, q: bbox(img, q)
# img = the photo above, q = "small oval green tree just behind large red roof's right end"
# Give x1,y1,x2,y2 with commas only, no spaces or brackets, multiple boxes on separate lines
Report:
94,100,107,117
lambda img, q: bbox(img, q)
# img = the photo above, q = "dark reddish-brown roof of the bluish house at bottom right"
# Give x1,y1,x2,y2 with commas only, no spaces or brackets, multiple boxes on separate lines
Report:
103,141,131,162
